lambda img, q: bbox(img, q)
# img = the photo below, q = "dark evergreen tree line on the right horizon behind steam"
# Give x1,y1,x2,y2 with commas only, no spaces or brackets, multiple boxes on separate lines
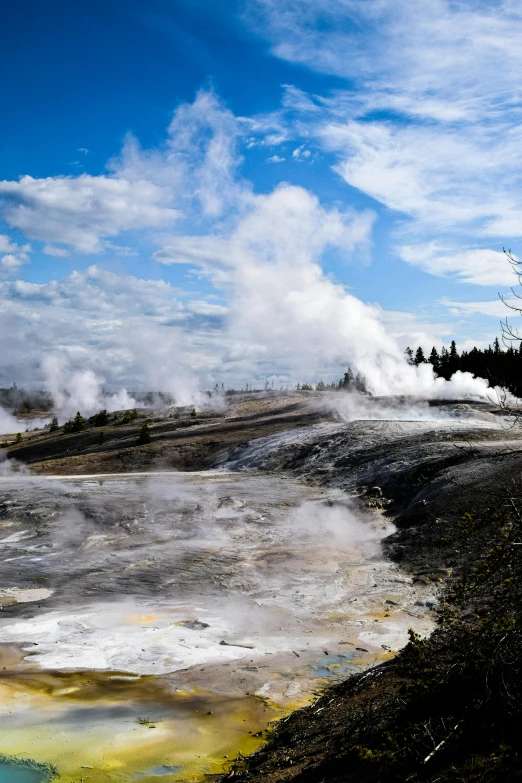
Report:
405,337,522,397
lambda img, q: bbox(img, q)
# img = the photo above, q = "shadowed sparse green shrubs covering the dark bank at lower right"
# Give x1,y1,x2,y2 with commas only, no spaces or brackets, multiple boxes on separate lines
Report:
342,496,522,783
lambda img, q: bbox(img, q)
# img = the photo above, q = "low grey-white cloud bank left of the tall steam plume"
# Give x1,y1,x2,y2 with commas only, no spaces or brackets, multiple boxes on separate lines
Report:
0,266,223,401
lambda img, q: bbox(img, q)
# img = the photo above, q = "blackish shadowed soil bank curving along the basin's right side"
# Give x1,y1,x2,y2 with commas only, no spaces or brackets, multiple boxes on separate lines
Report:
216,404,522,783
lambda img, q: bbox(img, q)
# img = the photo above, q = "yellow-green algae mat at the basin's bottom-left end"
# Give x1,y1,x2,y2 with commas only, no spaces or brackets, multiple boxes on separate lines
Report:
0,672,288,783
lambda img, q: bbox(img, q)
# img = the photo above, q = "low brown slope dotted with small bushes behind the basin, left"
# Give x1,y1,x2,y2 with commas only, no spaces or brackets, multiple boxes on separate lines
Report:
8,393,332,475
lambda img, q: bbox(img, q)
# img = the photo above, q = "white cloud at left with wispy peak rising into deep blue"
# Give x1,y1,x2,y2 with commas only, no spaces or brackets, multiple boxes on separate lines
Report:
0,91,243,255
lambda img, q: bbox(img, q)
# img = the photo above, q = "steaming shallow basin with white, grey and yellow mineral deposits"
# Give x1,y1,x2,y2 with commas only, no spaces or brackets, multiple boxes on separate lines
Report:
0,471,431,783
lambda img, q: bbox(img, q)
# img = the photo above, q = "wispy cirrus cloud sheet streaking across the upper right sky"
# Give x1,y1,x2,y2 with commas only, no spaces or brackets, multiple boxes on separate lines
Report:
245,0,522,285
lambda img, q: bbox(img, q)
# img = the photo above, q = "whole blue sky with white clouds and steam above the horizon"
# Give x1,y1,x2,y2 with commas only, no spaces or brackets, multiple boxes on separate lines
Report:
0,0,522,389
